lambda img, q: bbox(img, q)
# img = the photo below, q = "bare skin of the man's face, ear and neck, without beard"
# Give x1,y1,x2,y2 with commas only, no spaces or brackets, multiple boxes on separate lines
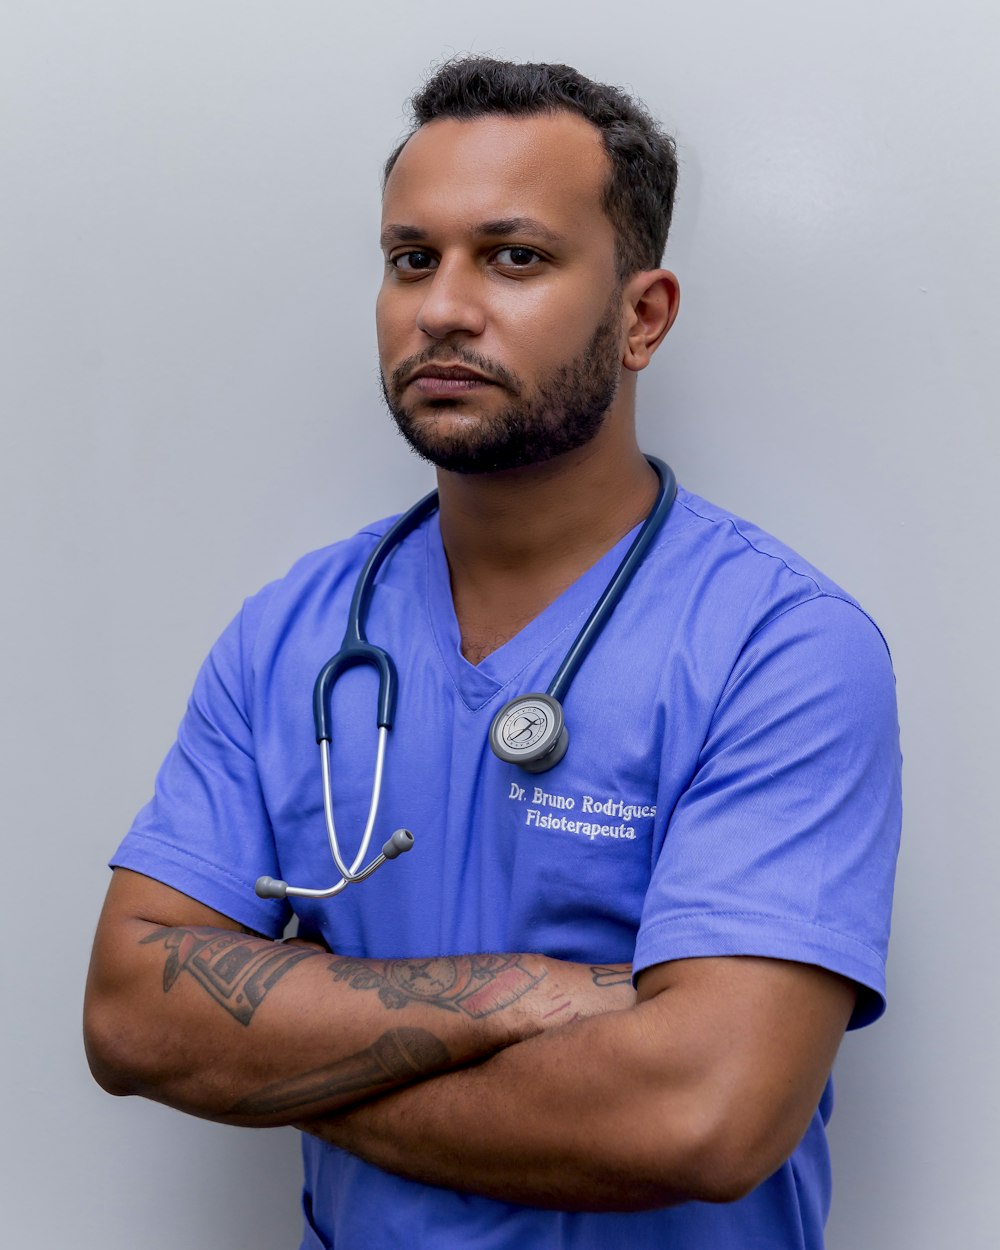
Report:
376,114,680,663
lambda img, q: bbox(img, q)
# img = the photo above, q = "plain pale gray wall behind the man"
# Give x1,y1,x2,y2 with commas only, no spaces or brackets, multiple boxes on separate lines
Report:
0,0,1000,1250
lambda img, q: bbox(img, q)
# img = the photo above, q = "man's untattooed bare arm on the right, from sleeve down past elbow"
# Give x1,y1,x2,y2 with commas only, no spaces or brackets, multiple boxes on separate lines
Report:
299,959,854,1211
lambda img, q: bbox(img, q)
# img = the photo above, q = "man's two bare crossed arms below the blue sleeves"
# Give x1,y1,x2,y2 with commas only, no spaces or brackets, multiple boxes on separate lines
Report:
85,870,854,1210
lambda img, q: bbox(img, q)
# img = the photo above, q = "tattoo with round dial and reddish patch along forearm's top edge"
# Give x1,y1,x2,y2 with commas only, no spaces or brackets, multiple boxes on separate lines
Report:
330,955,545,1019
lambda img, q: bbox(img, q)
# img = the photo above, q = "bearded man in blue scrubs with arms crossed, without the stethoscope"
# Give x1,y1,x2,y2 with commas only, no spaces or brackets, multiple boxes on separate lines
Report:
86,59,899,1250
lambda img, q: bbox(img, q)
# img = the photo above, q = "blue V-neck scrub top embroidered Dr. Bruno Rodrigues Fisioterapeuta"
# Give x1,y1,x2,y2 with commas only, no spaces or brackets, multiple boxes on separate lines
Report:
113,489,900,1250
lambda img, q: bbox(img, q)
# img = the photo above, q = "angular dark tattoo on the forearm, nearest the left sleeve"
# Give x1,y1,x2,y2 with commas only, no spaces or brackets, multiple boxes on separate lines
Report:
140,929,323,1025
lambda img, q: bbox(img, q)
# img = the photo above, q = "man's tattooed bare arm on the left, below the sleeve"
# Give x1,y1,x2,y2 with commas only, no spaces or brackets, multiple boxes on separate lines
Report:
85,875,632,1125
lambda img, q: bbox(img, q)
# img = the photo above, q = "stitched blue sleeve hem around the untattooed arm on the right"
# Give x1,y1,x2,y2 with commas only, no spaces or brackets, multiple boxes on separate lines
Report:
633,913,885,1029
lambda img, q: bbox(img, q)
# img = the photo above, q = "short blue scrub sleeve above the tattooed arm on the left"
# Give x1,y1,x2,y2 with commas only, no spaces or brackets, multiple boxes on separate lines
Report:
111,596,290,938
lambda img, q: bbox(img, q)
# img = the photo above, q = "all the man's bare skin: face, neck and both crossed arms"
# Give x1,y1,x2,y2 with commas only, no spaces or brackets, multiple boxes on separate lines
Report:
85,114,855,1210
